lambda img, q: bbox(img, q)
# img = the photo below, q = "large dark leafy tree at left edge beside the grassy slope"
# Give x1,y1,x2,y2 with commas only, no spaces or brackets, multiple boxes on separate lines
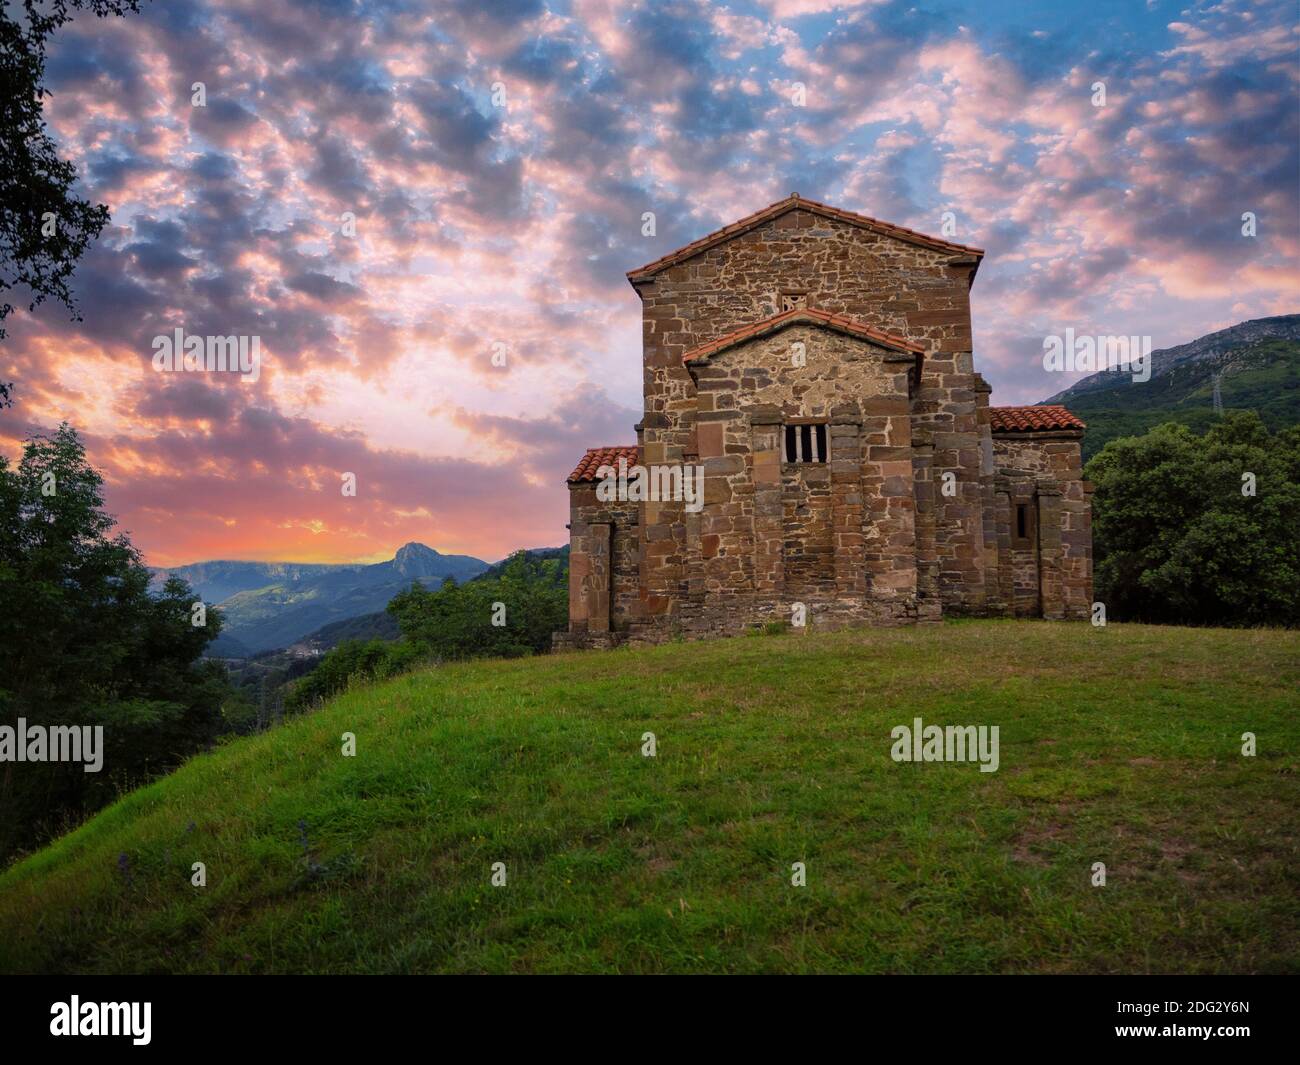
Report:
0,424,228,860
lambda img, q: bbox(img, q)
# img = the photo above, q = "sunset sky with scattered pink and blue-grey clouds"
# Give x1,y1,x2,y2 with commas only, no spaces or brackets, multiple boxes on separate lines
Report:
0,0,1300,566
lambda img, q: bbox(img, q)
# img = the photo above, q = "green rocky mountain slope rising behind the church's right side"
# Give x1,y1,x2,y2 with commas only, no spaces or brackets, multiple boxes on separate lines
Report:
1041,315,1300,462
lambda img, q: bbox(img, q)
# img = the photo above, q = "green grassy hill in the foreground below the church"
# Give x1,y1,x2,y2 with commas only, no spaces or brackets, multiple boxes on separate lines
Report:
0,622,1300,973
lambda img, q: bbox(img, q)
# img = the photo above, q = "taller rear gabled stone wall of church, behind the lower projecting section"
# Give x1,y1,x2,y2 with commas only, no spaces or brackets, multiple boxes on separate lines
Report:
636,209,984,642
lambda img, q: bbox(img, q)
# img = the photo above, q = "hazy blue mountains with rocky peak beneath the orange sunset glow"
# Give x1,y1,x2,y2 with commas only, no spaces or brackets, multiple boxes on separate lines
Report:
155,544,488,657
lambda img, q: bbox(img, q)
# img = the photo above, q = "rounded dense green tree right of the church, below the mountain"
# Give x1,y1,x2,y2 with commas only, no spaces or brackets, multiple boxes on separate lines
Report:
1087,411,1300,625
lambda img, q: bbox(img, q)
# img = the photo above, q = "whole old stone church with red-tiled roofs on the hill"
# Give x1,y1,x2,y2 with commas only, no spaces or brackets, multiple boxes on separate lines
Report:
555,194,1092,648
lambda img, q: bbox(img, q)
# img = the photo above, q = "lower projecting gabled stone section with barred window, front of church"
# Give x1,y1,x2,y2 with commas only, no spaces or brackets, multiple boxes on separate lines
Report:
660,324,917,638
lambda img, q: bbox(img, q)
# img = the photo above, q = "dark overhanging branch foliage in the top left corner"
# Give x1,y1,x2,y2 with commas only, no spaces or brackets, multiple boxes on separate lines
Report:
0,0,139,340
